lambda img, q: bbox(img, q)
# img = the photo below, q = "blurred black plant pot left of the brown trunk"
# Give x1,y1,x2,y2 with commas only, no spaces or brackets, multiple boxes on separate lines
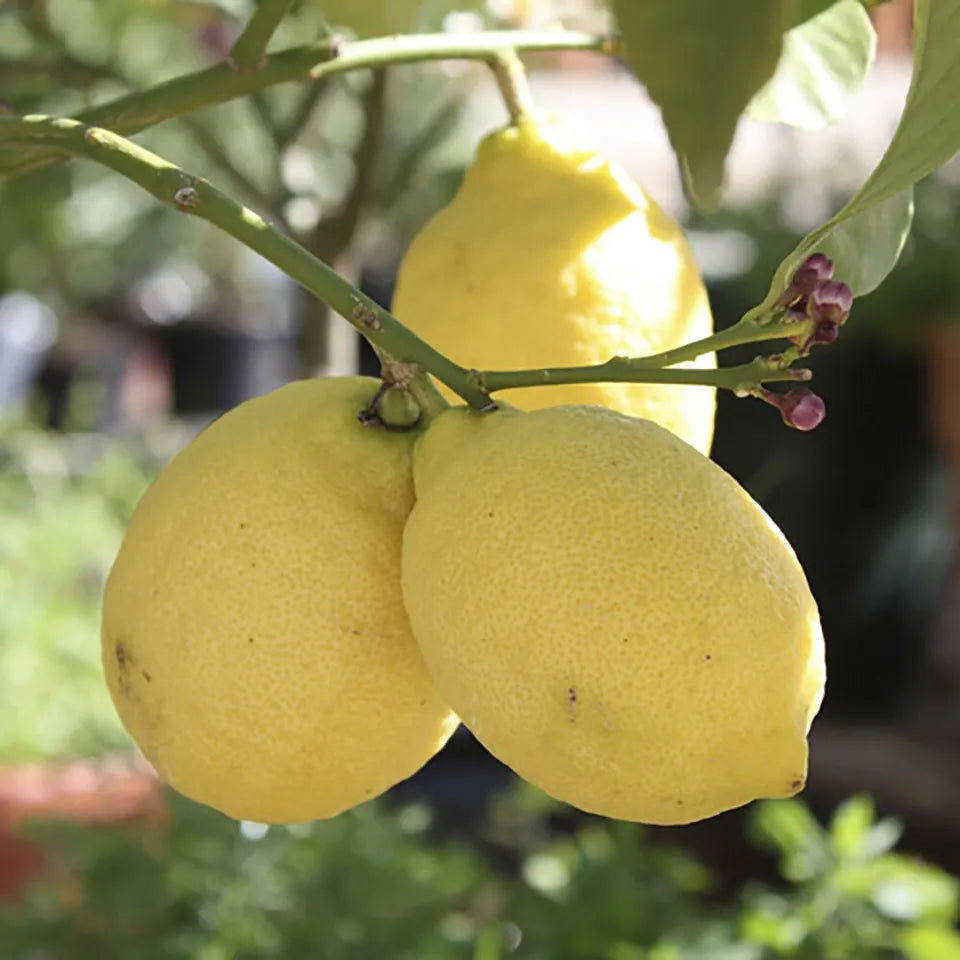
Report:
160,318,296,415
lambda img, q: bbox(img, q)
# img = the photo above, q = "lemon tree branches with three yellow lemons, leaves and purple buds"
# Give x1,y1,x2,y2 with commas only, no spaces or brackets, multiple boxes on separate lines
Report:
0,0,960,823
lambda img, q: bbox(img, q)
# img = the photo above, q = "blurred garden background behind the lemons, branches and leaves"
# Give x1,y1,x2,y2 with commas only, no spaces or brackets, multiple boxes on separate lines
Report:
0,0,960,960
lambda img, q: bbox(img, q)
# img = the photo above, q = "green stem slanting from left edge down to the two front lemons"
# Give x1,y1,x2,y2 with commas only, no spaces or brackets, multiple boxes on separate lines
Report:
0,116,489,407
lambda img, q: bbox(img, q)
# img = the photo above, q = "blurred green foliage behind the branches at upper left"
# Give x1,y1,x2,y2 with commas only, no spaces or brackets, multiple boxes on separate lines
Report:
0,0,476,322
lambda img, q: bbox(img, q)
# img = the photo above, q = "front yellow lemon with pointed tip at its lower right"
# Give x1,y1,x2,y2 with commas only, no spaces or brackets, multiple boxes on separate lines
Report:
403,406,825,824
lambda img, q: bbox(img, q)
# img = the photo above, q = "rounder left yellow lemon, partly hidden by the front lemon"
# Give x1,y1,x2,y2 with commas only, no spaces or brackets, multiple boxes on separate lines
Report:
102,377,457,823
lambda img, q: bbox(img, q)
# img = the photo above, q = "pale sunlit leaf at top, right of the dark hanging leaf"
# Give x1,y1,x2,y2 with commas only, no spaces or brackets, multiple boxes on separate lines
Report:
747,0,877,130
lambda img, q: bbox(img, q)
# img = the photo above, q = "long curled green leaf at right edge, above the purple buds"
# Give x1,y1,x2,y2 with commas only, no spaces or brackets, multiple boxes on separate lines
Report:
748,0,960,317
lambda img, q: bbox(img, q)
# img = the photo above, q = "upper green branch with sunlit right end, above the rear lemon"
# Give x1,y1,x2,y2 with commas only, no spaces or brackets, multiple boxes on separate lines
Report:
0,30,610,175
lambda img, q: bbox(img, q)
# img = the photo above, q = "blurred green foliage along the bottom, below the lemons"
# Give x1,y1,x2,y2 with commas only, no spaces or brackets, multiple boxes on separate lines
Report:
0,787,960,960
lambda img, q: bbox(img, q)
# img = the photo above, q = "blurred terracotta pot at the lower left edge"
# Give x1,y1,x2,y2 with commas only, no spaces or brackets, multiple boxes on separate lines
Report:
0,753,165,900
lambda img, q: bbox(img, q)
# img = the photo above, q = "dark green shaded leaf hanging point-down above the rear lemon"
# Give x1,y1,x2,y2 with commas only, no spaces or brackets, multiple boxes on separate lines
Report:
611,0,785,210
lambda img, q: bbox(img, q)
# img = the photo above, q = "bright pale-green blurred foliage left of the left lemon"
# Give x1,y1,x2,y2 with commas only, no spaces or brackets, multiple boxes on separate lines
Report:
0,428,147,760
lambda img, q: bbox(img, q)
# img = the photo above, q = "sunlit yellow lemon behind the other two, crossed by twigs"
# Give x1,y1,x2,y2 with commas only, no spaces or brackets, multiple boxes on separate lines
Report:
393,117,715,453
